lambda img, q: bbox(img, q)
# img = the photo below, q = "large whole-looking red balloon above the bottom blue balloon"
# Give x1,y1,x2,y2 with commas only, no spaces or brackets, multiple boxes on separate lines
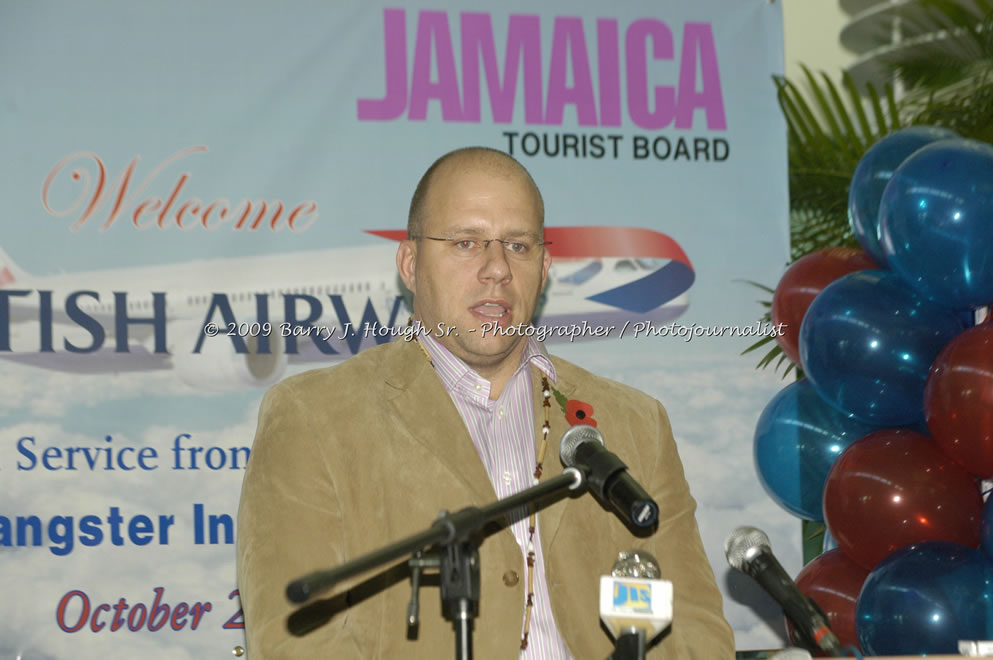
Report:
824,429,983,570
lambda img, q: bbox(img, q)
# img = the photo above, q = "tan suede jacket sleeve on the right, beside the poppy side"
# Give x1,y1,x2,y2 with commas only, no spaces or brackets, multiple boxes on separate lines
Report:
649,402,735,660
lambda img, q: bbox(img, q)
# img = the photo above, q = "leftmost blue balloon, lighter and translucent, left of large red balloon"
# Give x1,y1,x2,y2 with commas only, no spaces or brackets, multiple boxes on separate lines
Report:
754,378,879,521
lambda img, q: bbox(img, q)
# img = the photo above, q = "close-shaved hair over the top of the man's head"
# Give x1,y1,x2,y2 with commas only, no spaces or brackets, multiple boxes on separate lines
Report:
407,147,545,238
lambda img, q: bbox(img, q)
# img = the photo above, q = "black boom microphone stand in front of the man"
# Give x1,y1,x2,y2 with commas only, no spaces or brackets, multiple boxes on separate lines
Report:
286,468,586,660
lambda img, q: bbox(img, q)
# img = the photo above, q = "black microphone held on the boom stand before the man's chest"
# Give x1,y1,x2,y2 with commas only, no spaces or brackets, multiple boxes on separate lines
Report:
559,424,659,527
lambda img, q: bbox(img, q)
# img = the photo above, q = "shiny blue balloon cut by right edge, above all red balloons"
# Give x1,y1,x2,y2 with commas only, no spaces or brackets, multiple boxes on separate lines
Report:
879,139,993,309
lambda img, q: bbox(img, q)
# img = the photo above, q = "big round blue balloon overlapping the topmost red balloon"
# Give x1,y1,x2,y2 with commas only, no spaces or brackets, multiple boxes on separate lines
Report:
799,270,964,426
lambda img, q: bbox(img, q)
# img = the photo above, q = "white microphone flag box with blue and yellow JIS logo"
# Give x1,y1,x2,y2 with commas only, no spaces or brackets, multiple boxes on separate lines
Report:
600,575,672,640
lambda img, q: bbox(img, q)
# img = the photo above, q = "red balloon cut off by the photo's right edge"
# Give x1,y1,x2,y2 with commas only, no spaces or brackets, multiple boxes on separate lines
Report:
924,321,993,479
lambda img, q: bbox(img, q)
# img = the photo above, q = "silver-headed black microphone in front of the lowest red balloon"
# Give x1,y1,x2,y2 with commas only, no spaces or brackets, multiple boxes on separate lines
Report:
724,527,843,657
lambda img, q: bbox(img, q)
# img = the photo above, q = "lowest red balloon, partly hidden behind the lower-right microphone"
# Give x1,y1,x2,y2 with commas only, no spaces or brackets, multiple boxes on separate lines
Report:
787,549,869,650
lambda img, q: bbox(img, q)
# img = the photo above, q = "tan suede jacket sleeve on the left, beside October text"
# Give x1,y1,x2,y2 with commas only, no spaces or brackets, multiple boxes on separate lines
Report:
237,382,361,660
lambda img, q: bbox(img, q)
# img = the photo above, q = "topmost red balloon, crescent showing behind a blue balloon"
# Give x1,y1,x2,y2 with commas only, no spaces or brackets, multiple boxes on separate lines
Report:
772,248,879,364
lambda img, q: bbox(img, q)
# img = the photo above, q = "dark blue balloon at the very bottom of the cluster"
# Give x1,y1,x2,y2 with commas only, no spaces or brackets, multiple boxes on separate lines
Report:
855,541,993,655
